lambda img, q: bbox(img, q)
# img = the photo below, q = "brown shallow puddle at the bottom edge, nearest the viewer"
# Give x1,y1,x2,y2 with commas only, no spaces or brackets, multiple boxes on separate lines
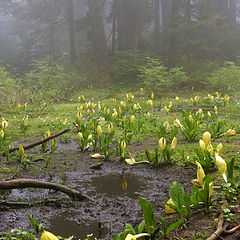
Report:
49,212,109,239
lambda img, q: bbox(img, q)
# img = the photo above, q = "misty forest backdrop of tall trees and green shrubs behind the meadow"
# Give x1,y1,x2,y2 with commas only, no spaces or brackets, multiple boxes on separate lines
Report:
0,0,240,101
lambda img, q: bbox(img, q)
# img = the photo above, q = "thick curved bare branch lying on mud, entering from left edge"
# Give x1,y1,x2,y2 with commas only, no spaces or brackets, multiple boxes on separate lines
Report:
0,178,92,201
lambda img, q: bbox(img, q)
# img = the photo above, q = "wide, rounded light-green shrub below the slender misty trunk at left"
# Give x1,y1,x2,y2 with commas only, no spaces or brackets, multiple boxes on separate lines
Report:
21,58,82,103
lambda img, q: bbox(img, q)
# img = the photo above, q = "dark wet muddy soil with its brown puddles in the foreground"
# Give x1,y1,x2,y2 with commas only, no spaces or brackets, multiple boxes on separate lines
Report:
0,141,240,240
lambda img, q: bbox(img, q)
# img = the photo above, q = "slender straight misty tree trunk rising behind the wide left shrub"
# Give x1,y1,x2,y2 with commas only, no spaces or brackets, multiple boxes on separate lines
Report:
66,0,76,64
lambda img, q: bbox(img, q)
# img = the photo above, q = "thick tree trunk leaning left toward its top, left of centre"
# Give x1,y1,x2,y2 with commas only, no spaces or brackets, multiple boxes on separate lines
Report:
88,0,109,87
